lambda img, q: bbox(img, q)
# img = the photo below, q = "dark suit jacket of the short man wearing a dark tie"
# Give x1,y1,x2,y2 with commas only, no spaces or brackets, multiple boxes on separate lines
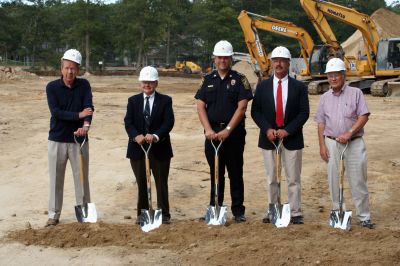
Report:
124,92,175,160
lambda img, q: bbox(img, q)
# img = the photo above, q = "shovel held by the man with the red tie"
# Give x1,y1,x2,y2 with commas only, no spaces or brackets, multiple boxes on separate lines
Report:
269,139,290,228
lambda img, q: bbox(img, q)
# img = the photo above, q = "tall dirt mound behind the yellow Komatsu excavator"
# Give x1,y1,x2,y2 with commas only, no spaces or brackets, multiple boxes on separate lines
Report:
342,8,400,57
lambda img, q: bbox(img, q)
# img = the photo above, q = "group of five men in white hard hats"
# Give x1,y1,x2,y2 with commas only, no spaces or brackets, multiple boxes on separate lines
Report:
46,40,373,228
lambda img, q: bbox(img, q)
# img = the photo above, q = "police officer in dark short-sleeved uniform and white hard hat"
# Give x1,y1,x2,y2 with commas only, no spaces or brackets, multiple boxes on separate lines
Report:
195,40,253,223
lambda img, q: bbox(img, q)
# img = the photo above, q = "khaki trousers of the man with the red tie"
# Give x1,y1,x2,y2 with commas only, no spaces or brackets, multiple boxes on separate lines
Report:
261,145,303,217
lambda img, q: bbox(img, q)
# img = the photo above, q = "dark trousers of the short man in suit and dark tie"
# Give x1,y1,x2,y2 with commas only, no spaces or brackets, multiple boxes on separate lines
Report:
130,153,171,218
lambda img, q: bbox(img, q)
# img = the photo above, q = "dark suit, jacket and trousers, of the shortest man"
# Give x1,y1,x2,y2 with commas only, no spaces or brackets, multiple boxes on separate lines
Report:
124,92,175,218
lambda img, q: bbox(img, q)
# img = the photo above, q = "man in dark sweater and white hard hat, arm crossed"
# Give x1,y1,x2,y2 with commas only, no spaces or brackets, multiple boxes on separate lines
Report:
46,49,94,226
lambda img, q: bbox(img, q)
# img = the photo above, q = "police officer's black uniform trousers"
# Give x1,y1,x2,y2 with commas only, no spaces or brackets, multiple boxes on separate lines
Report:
205,127,246,216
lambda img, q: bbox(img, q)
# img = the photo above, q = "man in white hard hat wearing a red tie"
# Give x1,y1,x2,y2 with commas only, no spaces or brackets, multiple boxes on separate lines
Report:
251,46,310,224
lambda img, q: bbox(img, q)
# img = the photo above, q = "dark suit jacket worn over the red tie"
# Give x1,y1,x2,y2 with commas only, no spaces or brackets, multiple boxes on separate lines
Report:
251,76,310,150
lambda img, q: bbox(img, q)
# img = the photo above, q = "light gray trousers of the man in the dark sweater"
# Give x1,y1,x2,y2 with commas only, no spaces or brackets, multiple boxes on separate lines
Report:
48,140,90,219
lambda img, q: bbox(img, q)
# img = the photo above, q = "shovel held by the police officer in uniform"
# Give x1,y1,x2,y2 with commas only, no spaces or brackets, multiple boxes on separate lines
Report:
205,140,227,225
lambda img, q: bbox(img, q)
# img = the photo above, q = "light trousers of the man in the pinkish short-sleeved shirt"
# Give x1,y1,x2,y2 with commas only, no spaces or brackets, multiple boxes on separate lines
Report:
325,138,371,221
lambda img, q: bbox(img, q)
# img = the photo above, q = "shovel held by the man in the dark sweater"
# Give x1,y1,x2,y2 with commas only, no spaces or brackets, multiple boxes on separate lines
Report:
74,134,97,223
